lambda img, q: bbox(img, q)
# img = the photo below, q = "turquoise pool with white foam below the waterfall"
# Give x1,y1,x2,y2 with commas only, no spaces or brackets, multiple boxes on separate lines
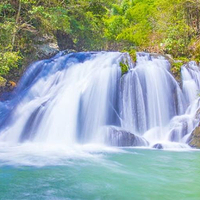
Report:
0,146,200,200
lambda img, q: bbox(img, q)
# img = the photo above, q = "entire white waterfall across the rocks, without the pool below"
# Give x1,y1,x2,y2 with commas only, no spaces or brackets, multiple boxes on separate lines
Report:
0,52,200,148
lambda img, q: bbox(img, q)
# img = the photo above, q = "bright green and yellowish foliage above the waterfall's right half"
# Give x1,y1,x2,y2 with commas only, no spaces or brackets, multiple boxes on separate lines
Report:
105,0,200,57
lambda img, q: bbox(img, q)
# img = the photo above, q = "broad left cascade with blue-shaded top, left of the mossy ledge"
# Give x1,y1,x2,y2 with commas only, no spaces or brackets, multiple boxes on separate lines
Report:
1,53,121,145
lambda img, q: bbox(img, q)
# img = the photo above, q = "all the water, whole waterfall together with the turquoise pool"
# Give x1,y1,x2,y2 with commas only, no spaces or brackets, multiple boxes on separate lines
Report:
0,52,200,199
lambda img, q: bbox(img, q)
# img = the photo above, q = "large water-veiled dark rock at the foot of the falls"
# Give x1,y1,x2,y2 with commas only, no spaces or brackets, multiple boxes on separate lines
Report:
105,127,149,147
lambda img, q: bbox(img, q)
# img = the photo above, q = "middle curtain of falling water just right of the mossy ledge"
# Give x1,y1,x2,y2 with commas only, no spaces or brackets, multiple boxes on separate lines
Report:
122,54,183,133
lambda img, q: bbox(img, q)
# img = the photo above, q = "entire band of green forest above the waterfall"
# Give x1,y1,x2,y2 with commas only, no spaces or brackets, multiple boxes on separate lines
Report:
0,0,200,76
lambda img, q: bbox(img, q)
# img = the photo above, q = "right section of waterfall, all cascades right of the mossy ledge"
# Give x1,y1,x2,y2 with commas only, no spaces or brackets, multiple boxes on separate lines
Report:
121,53,200,148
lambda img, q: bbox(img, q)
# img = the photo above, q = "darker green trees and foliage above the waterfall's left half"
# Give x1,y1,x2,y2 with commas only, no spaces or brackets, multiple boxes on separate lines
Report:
0,0,115,75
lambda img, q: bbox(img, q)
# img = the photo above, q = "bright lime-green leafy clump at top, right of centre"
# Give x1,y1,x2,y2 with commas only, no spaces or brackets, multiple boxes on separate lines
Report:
105,0,154,47
